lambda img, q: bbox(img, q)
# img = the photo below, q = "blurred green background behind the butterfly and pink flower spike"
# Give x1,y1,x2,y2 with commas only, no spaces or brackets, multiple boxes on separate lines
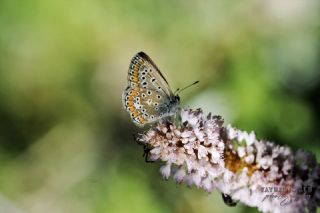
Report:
0,0,320,213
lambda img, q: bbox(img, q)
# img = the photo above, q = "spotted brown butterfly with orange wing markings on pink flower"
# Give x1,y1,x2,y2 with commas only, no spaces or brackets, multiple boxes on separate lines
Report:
122,52,180,127
